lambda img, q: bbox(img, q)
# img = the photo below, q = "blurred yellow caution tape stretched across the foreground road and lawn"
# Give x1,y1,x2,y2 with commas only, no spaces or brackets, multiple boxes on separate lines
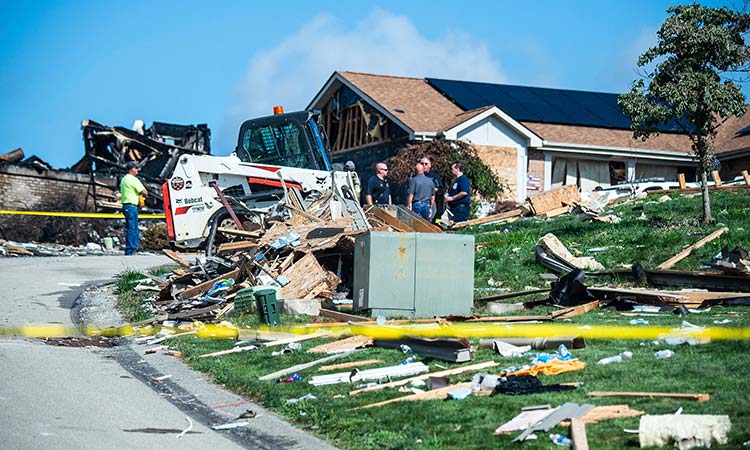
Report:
0,323,750,341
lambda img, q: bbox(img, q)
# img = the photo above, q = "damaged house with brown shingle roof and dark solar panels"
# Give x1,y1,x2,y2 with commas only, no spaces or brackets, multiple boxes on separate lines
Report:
308,72,750,201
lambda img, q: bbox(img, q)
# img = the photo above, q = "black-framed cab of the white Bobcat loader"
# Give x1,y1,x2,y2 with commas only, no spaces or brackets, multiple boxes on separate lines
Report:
235,111,331,171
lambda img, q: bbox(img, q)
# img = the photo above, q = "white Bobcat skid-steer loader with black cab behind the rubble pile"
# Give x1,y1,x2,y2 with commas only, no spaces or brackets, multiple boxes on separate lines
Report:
162,107,368,256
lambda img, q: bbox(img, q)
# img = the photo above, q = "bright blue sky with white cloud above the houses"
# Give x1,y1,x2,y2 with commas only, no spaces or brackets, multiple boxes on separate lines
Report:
0,0,750,168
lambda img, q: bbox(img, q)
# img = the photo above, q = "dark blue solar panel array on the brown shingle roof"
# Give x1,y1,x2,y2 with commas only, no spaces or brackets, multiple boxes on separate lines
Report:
426,78,681,132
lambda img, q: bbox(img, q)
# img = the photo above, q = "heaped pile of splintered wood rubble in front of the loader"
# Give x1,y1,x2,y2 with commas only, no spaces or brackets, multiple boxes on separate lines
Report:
131,195,442,322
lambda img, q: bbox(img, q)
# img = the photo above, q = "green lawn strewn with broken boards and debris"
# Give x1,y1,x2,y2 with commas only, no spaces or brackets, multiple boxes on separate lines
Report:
117,192,750,449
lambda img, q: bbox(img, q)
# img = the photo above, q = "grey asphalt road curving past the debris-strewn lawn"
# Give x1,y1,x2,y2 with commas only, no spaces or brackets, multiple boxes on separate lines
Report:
0,256,338,450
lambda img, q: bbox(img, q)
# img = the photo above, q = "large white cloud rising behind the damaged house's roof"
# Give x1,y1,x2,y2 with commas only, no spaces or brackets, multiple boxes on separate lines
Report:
219,10,506,148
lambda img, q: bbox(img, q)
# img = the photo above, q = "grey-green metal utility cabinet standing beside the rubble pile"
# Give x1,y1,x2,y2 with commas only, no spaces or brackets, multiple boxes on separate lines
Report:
352,231,474,317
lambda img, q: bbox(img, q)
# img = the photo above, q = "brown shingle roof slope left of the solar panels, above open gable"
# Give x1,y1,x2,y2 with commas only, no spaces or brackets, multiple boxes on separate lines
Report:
338,72,464,131
